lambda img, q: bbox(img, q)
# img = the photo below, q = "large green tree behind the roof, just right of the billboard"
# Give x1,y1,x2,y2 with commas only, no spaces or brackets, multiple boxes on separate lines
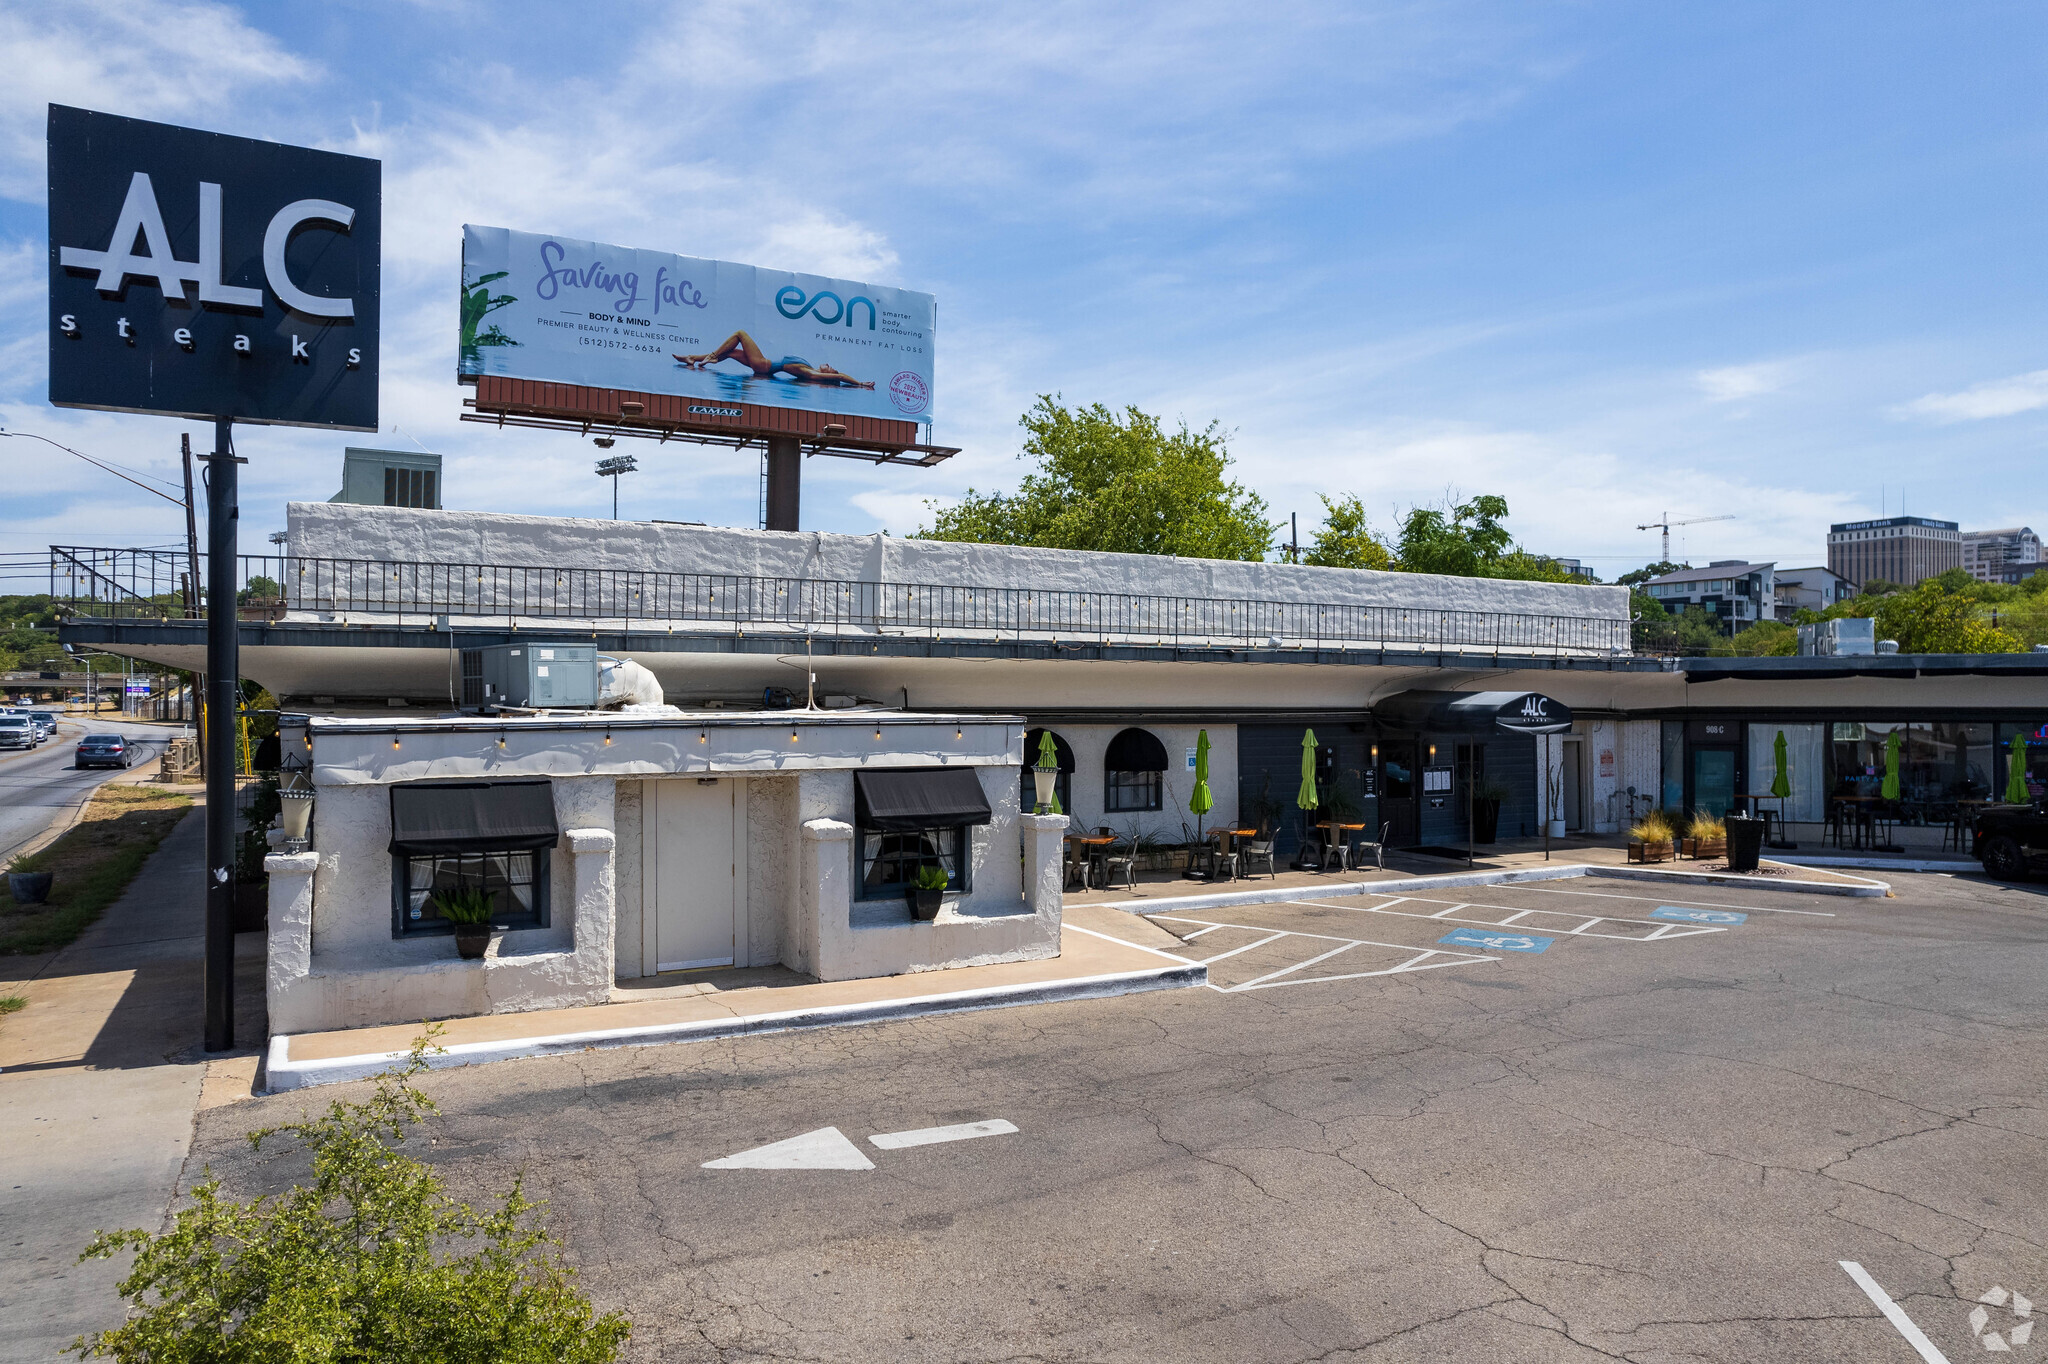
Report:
918,393,1274,559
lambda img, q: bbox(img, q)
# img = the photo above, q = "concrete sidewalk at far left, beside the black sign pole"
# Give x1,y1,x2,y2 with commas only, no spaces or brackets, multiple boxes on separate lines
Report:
0,805,264,1364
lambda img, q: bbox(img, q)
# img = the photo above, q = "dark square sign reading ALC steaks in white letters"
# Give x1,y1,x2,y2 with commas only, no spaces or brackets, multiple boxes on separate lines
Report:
49,104,383,430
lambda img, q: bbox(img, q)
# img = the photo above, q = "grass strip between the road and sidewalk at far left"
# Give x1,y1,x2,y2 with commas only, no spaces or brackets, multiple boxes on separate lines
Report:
0,782,193,956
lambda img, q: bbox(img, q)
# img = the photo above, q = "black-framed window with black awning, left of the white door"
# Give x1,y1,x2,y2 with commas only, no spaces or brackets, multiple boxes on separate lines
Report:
391,780,561,938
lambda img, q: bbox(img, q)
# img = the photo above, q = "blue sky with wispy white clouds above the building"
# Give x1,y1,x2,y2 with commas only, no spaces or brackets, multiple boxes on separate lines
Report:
0,0,2048,578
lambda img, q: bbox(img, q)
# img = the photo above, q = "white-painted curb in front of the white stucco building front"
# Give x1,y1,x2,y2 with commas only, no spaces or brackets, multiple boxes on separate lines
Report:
262,963,1208,1094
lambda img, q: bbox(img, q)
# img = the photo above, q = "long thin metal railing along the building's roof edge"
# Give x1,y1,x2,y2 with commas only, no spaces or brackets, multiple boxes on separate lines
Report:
49,545,1630,653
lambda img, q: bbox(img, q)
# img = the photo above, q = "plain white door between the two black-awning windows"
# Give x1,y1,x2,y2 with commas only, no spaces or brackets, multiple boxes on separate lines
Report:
641,776,745,971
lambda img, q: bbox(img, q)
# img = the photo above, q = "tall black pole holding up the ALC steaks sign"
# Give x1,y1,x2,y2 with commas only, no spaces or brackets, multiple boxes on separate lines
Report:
203,418,244,1051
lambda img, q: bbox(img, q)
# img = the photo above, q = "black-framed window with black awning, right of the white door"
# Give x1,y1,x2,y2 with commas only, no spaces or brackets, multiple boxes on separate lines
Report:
854,768,991,899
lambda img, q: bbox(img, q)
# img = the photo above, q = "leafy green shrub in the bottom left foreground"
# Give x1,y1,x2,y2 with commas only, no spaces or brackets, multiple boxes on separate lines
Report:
72,1030,631,1364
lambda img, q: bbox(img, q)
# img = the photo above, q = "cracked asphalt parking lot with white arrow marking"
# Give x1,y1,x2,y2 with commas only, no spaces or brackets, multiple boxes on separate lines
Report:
188,875,2048,1364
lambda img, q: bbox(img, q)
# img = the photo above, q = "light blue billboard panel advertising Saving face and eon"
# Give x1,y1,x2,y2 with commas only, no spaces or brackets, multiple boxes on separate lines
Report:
457,225,938,422
